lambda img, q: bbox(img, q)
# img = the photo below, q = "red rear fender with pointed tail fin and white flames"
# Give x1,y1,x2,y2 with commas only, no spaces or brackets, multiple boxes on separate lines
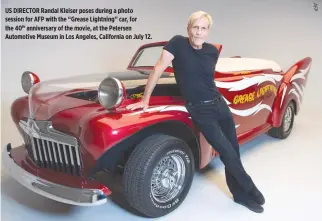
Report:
272,57,312,127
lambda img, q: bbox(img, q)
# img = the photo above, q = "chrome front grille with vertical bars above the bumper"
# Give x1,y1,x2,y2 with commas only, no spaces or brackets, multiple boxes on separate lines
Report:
20,119,82,176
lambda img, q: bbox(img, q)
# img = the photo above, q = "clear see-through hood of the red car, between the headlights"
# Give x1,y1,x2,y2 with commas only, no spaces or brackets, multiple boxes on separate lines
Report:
29,70,174,120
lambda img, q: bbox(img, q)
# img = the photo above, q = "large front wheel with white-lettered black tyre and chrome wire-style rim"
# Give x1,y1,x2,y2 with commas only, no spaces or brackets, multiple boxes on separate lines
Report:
123,134,194,218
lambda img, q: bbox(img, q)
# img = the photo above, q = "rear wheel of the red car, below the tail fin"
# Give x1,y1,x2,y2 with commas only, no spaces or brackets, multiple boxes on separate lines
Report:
268,102,295,139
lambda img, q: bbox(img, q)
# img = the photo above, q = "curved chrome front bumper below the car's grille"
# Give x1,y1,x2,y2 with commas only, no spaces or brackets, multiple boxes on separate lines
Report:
2,144,107,206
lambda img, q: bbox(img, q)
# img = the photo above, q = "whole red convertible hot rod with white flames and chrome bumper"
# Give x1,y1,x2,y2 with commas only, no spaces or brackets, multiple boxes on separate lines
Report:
2,42,312,217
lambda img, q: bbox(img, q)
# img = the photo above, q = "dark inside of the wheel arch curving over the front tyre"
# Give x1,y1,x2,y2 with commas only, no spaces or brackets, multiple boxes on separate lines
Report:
90,120,200,175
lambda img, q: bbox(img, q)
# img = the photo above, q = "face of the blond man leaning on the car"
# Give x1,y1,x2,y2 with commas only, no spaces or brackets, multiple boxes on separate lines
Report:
187,18,209,48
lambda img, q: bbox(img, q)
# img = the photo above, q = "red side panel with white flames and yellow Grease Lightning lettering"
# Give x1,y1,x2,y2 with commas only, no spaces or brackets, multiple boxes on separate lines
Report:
215,71,278,134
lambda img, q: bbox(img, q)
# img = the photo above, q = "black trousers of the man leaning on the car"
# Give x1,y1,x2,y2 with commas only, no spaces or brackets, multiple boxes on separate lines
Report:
185,95,254,199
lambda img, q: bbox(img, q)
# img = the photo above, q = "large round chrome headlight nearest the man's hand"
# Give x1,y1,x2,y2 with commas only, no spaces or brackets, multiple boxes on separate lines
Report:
98,77,125,110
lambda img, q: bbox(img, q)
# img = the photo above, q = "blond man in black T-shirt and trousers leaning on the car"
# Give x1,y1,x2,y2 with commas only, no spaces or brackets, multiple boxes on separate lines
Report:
127,11,265,213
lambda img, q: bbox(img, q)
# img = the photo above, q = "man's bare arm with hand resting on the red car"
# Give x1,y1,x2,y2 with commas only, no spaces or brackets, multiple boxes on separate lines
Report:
126,50,174,110
